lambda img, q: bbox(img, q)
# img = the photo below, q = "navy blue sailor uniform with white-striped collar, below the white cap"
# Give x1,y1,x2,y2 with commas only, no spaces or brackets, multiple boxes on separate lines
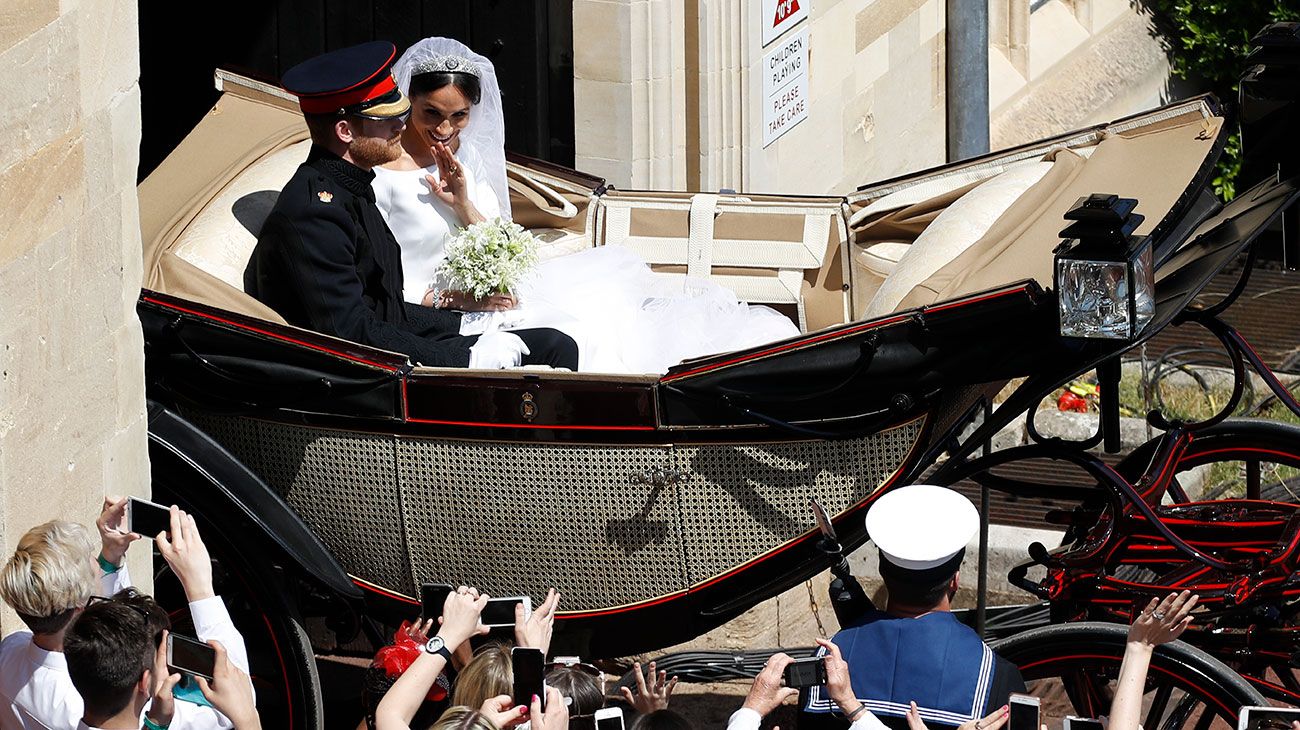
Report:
800,610,1024,729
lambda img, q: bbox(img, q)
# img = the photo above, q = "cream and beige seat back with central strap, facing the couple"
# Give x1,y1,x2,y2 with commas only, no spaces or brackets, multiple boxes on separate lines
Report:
594,190,850,331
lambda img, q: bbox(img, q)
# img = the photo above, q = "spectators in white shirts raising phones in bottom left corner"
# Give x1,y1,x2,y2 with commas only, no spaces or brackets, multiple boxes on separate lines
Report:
0,496,261,730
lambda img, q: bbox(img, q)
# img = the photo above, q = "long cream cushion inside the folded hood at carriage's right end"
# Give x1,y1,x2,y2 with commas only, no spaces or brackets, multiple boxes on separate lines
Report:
865,161,1053,318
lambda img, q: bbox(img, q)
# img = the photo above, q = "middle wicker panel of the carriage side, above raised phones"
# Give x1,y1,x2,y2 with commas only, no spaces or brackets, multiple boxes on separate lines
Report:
398,439,686,610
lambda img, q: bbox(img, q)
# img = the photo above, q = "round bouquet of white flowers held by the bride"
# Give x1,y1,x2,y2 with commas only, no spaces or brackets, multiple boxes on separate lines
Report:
438,218,537,299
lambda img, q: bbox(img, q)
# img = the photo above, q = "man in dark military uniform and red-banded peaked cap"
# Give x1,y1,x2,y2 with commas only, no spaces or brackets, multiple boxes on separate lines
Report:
244,40,577,370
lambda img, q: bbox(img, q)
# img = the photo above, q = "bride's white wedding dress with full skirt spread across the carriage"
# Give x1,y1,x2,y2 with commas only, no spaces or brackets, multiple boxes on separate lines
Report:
373,145,798,374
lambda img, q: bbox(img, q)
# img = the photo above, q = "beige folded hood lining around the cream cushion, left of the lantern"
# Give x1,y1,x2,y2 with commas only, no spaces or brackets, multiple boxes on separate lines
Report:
850,107,1222,317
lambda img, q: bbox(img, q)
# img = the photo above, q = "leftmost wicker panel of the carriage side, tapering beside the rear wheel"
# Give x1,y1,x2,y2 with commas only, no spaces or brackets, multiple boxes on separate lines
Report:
186,410,416,596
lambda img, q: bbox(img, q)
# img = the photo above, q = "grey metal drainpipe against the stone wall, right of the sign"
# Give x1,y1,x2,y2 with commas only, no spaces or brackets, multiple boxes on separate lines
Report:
944,0,988,162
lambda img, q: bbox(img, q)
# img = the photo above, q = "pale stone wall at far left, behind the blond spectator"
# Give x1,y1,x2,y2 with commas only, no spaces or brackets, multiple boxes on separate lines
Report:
0,0,150,633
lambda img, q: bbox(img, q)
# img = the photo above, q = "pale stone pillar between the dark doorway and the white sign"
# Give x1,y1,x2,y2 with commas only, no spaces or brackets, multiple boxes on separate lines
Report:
573,0,686,188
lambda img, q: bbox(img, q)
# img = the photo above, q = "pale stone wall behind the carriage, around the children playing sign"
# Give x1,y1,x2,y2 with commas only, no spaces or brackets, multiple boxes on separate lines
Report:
573,0,1169,194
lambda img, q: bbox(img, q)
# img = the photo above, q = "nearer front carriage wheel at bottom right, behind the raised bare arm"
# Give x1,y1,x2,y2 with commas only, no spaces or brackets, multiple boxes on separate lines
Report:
993,622,1268,730
